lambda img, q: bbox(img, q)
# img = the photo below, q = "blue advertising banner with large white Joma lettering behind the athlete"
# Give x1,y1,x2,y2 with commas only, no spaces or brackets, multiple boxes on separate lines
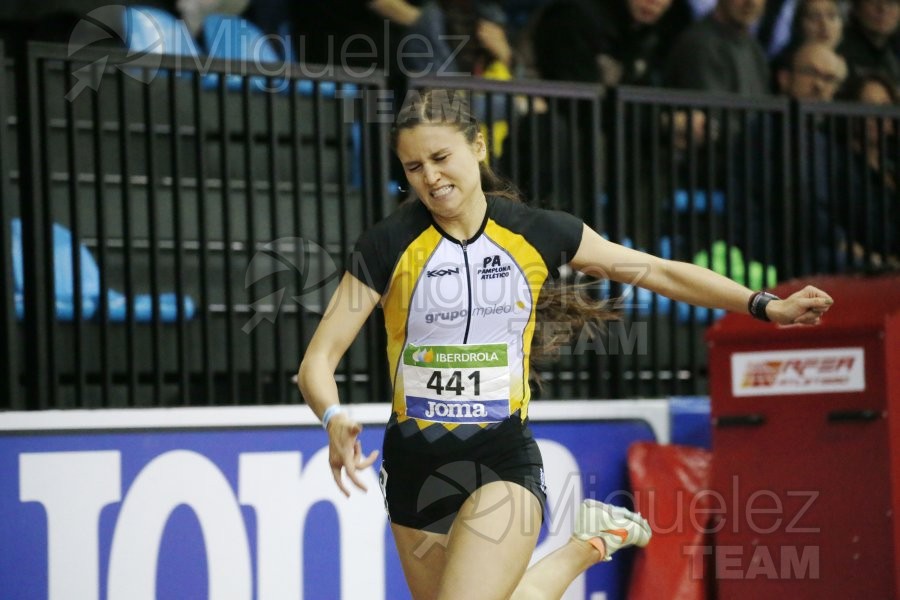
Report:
0,401,669,600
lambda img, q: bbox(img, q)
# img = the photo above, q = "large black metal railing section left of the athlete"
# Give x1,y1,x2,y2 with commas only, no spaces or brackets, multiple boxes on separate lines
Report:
4,44,387,409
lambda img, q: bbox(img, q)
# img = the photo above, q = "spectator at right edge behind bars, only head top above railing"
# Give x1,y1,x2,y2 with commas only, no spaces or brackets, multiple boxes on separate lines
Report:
840,71,900,269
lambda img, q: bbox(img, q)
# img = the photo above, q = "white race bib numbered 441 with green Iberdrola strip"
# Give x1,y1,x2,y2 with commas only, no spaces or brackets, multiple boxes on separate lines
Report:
403,343,509,423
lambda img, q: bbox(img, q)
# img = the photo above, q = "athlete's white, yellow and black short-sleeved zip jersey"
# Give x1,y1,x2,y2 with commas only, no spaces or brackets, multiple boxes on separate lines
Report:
349,197,583,430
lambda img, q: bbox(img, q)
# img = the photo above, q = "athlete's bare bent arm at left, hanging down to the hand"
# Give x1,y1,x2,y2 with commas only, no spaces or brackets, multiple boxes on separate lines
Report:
297,273,381,496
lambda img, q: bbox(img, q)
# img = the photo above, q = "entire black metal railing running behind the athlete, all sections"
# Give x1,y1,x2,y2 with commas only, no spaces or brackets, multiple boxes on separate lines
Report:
0,44,900,409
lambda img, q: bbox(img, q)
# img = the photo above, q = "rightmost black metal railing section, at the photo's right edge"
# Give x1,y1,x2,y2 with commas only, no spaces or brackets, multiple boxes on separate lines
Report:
792,103,900,276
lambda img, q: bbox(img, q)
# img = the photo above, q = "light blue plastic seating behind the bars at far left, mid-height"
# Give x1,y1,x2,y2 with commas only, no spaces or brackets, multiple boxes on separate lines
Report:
11,219,196,322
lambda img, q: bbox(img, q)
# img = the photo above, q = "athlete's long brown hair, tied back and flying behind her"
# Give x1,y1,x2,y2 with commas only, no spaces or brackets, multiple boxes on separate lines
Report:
391,89,620,384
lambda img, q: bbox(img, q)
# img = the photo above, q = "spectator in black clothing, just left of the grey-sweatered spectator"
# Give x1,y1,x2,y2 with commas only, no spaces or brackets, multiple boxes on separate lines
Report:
532,0,691,86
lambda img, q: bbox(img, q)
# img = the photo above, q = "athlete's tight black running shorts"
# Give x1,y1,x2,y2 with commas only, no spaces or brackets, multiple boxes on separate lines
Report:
380,413,547,533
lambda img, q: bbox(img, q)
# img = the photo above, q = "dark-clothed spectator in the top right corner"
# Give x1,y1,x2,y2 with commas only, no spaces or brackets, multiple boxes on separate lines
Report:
838,0,900,85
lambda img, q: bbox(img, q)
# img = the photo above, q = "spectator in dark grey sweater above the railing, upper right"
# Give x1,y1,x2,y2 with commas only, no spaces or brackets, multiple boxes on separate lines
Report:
664,0,770,96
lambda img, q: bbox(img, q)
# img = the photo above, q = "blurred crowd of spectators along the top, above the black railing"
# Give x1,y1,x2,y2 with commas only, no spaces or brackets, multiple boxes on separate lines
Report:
0,0,900,264
